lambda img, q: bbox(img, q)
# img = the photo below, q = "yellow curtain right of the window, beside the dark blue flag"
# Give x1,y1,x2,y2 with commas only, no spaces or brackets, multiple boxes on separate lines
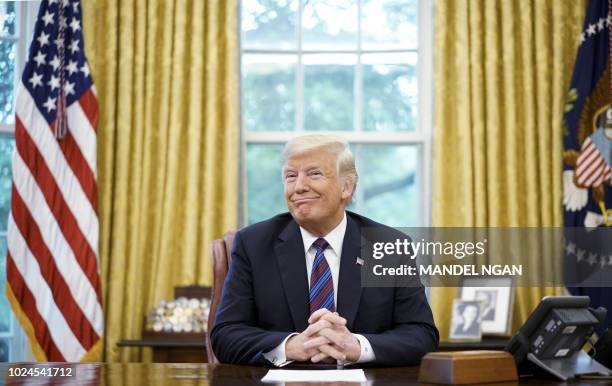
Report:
432,0,586,338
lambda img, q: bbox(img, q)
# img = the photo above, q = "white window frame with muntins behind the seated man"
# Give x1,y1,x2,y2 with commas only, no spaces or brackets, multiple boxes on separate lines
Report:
238,0,434,227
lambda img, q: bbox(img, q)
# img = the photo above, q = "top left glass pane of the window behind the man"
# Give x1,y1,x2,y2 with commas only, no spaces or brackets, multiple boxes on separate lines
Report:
242,0,298,49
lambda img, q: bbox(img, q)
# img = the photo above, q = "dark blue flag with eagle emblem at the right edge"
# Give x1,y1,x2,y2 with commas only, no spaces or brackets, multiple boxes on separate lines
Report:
563,0,612,325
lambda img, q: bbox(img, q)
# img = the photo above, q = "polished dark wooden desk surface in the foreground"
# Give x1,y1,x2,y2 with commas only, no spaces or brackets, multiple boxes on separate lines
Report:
0,363,612,386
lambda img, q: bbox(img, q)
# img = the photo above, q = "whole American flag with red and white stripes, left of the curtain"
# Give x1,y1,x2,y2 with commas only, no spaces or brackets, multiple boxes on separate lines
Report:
6,0,104,361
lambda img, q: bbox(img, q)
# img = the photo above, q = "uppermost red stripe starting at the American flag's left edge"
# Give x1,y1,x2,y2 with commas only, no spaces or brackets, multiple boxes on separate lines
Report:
15,118,102,301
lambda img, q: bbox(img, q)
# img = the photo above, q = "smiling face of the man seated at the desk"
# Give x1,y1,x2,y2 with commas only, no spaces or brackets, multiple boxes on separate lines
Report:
283,149,352,231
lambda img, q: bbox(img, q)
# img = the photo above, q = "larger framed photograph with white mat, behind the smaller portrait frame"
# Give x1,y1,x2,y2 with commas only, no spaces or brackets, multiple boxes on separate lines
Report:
459,278,514,336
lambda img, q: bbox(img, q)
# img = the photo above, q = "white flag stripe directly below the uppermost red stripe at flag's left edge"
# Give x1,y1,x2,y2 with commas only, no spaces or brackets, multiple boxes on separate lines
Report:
13,146,103,335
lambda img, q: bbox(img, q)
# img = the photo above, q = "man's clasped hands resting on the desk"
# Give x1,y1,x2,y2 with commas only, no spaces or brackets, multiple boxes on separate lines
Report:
285,308,361,363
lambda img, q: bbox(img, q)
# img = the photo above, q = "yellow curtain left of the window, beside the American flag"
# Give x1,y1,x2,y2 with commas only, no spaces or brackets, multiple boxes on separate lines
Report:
82,0,239,361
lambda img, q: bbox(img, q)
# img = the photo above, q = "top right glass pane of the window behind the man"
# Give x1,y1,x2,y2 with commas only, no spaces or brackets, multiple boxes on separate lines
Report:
361,0,418,50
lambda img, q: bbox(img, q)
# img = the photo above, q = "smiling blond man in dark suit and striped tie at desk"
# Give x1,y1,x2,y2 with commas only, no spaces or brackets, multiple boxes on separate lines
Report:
211,135,439,366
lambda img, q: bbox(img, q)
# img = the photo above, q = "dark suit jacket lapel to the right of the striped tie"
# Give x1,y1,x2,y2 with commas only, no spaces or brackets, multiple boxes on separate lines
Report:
336,213,361,330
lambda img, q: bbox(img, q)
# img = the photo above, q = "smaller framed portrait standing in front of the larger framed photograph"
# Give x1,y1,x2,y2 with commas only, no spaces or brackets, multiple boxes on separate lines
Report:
450,299,482,342
